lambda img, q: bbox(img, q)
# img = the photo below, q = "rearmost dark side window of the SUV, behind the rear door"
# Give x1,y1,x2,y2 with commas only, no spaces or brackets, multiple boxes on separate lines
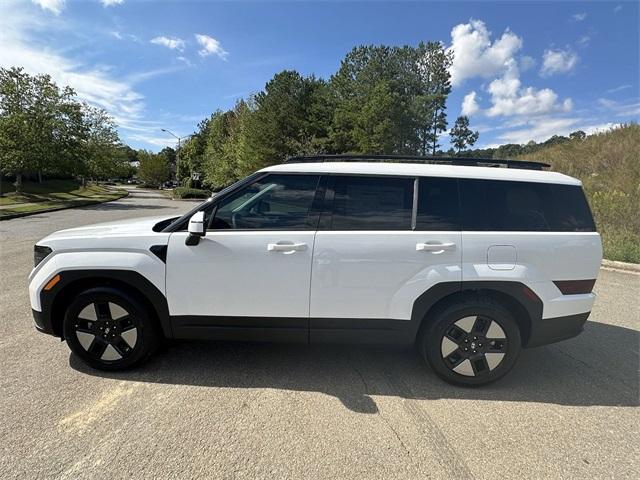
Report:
460,180,595,232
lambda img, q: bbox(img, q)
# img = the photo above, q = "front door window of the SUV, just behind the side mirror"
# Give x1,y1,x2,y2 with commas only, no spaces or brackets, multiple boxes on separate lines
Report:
210,175,320,230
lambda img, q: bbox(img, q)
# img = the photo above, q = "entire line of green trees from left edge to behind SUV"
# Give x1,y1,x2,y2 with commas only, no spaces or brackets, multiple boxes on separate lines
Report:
0,42,478,191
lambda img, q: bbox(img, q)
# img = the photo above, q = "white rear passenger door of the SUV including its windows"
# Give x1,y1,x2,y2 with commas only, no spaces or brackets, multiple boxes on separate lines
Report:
310,175,461,341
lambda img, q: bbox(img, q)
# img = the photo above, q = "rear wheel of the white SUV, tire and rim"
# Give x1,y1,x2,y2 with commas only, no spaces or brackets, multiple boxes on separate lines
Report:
419,298,522,387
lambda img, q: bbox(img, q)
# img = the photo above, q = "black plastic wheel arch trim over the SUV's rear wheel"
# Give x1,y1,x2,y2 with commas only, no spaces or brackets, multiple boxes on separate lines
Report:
411,281,542,346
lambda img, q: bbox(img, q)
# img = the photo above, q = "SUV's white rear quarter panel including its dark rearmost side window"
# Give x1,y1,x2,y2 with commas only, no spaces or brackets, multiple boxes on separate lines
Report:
460,179,602,318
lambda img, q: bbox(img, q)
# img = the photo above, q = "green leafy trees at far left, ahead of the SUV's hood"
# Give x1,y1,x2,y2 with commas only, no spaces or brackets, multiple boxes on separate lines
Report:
0,67,131,192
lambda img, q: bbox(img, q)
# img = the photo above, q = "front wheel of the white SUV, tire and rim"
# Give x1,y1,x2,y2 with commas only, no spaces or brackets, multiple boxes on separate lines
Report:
63,287,161,371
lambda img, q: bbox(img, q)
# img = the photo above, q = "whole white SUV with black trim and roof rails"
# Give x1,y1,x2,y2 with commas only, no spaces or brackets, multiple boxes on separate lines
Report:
29,156,602,385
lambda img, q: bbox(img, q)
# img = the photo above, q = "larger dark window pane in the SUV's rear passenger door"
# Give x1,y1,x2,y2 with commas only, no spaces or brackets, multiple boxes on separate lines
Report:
328,176,413,230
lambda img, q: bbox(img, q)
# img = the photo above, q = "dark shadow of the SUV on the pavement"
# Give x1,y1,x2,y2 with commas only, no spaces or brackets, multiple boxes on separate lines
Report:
69,322,640,413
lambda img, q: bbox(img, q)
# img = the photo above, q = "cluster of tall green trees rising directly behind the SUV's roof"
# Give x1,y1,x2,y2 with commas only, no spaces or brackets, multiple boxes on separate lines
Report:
177,42,478,188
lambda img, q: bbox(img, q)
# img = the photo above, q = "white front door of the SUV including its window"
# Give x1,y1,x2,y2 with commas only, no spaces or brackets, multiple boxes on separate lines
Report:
166,174,319,341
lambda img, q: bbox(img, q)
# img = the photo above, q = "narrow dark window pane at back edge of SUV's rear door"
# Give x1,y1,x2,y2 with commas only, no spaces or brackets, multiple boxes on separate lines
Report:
416,177,460,230
